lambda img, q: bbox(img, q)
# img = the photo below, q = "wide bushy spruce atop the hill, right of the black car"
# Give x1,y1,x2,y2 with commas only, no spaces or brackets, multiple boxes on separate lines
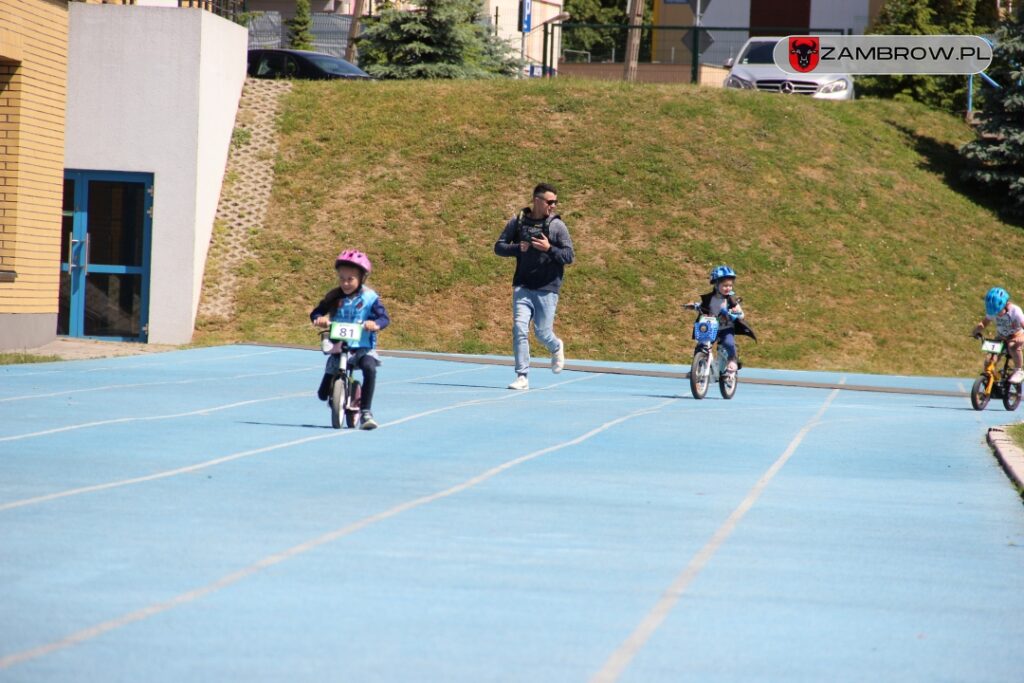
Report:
357,0,520,79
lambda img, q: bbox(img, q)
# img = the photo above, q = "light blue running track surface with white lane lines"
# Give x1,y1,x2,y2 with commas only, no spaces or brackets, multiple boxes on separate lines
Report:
0,346,1024,682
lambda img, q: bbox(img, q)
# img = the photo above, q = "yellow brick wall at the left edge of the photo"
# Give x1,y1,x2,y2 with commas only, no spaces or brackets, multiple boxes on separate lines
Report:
0,0,68,313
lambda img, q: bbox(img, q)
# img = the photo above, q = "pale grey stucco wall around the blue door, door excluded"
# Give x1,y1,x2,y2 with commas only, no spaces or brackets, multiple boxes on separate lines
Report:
65,2,248,344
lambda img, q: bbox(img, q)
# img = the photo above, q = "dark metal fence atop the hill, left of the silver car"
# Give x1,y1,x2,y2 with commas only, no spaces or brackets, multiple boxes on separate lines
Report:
557,24,852,82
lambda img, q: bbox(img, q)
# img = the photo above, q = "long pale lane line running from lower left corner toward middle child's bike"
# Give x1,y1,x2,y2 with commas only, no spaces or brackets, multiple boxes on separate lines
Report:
0,393,679,669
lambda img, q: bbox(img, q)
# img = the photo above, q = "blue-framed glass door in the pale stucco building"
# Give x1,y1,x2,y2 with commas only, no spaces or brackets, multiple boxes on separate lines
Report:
57,171,153,341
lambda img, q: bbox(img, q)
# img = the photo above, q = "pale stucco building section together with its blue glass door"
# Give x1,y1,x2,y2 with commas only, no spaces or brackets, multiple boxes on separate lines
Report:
65,2,247,344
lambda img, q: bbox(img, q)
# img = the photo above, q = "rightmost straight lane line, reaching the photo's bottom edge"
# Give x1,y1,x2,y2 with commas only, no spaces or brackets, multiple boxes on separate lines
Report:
590,377,846,683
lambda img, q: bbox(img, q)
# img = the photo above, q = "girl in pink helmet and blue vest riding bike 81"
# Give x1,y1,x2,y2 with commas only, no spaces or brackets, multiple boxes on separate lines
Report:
309,249,391,429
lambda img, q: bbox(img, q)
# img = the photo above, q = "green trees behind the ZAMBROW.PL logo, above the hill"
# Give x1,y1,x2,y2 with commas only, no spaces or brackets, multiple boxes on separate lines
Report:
857,0,977,111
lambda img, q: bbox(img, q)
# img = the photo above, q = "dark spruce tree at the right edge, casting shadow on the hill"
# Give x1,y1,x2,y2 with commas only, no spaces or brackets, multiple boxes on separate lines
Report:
961,16,1024,218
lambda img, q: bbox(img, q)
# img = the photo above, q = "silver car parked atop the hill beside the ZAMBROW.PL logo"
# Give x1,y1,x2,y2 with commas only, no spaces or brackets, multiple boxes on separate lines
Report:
725,37,853,99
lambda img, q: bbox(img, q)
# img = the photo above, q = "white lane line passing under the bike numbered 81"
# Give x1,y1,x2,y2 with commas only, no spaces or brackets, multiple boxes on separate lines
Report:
0,375,596,512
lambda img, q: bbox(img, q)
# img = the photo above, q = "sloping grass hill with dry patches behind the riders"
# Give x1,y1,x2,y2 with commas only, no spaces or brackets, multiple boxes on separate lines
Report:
196,79,1024,376
